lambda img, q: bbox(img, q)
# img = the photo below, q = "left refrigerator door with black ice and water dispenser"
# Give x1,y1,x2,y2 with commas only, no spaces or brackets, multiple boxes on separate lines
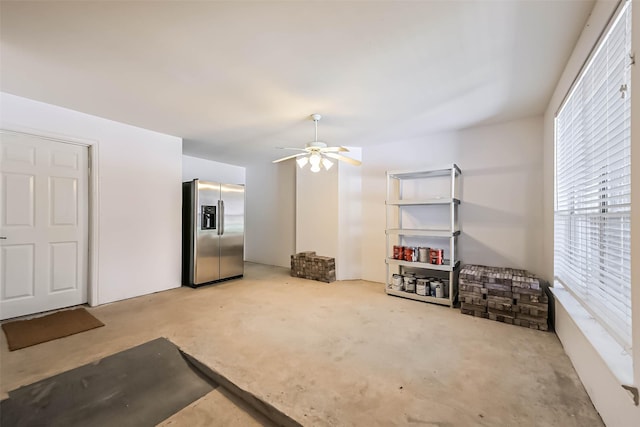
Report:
193,180,220,285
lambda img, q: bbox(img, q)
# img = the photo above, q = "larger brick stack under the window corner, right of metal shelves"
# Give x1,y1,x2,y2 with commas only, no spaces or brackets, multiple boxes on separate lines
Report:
458,265,549,331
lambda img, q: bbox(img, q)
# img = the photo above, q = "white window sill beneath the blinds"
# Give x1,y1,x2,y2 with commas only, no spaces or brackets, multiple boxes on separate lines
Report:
550,282,633,390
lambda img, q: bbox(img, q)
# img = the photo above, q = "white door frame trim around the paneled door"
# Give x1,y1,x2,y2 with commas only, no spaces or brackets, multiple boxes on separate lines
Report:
0,125,100,307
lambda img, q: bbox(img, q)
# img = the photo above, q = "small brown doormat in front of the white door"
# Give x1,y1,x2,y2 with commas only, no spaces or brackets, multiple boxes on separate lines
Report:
2,308,104,351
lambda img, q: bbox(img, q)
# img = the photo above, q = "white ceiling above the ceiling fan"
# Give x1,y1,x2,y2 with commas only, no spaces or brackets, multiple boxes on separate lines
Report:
0,0,594,165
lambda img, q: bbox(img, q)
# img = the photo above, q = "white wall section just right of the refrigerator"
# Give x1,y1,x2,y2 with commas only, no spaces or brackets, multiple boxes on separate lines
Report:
245,162,296,267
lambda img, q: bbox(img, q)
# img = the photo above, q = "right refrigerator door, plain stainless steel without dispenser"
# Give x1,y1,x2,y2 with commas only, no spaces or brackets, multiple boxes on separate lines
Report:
219,184,244,279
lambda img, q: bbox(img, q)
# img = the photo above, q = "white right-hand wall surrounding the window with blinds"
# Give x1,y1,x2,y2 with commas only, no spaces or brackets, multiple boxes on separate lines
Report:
543,1,640,426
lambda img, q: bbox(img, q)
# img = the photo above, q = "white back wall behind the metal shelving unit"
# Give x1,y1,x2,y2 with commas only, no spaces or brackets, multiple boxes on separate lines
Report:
362,117,542,282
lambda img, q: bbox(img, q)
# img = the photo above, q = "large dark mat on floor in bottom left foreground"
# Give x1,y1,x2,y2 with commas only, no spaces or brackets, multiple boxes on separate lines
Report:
0,338,218,427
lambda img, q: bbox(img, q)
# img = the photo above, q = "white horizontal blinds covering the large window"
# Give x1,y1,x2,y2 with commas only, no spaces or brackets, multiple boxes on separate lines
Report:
554,1,632,349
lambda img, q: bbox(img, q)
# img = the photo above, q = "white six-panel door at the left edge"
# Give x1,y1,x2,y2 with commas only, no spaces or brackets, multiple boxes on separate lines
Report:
0,131,89,319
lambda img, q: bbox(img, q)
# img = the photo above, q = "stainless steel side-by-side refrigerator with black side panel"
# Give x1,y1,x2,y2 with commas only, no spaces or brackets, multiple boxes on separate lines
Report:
182,179,244,287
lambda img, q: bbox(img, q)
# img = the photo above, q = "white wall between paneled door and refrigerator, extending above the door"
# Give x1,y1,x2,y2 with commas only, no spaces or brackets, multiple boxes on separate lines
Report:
0,93,182,304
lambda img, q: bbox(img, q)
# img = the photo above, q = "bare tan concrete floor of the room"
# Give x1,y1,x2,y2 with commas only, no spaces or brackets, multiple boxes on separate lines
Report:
0,263,603,427
